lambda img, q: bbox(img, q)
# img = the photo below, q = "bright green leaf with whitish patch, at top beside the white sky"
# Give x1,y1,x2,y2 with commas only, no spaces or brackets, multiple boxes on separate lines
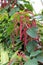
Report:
17,0,33,11
